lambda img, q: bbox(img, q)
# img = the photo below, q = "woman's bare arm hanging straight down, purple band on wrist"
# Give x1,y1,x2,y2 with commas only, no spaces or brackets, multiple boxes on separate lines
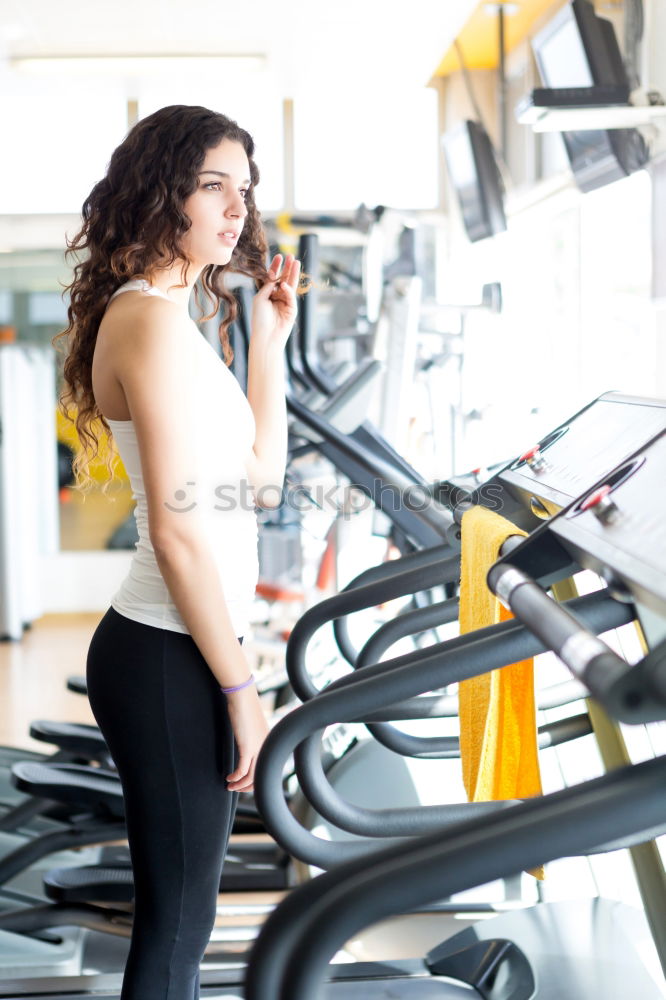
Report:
114,299,266,790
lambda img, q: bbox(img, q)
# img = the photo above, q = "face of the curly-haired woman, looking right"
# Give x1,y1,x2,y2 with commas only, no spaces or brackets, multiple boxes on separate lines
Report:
183,139,250,267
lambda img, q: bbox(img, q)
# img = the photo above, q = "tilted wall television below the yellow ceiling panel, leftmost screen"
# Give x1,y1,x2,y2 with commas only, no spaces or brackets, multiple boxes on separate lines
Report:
442,120,506,243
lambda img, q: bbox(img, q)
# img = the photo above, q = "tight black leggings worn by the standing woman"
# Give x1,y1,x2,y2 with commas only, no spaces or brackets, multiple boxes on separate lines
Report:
87,608,238,1000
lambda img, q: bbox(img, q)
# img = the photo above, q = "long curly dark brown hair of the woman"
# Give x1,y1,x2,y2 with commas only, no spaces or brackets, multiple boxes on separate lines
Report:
52,104,286,492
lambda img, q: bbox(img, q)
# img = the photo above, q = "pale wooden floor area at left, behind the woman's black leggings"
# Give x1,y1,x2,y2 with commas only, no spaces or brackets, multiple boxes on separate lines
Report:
0,614,102,752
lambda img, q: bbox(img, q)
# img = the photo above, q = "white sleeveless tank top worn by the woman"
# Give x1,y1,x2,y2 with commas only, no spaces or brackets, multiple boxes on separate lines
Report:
107,279,259,637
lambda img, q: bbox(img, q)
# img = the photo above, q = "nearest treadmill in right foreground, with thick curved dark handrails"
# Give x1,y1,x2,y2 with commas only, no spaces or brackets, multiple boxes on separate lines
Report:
245,433,666,1000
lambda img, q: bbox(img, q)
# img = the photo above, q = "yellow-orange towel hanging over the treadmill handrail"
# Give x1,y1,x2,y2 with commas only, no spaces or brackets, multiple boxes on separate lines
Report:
459,507,543,878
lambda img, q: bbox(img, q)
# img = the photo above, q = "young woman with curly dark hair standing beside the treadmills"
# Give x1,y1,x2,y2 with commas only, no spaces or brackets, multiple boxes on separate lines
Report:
55,105,300,1000
